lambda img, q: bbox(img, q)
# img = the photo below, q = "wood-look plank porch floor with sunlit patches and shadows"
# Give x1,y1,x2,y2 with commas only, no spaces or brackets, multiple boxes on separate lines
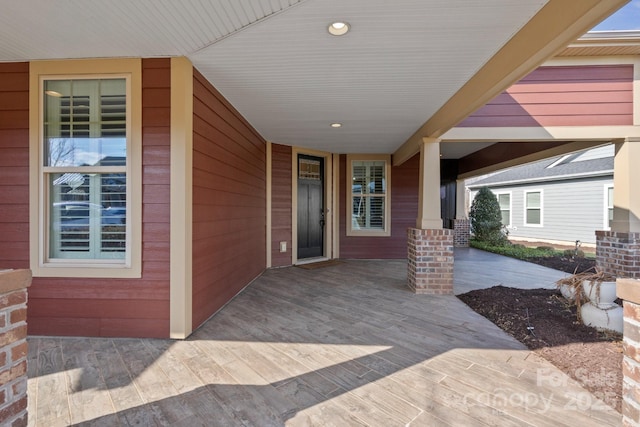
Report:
28,261,621,427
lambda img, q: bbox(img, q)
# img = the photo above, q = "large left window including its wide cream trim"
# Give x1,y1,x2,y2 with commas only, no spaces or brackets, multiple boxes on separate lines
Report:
32,62,141,277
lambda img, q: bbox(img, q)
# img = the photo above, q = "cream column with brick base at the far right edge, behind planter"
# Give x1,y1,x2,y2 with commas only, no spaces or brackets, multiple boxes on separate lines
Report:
596,138,640,279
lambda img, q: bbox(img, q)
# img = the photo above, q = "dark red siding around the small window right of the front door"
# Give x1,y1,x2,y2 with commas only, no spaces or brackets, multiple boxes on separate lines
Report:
339,154,420,259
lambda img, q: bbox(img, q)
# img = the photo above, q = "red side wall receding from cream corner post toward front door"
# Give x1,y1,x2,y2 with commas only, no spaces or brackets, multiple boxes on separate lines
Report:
193,70,266,328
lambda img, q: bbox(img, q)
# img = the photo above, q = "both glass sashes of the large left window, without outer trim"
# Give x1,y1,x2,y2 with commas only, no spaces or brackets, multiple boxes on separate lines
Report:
42,78,128,262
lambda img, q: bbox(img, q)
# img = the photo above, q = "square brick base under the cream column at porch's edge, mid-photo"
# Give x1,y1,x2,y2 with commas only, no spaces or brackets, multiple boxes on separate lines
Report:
407,228,453,295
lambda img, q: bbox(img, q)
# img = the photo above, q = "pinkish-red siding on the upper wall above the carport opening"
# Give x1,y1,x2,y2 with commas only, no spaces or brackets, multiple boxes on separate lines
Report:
459,65,633,127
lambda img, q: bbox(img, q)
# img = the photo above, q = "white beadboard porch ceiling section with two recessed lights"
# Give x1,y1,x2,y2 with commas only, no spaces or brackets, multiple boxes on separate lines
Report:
190,0,546,153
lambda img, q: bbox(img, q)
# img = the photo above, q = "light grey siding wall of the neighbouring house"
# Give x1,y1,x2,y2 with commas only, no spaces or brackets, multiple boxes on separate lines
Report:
469,176,613,244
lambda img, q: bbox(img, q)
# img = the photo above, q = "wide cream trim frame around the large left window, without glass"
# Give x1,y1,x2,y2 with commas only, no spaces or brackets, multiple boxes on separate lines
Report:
29,59,142,278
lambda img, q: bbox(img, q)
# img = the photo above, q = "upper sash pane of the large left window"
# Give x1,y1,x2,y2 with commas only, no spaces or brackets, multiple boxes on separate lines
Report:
44,79,127,167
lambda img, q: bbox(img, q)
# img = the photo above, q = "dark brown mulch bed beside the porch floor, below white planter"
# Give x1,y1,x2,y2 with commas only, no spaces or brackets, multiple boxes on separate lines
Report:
458,259,623,412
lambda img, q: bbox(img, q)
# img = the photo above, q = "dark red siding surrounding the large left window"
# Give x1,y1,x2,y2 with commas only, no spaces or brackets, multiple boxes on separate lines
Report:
12,59,170,337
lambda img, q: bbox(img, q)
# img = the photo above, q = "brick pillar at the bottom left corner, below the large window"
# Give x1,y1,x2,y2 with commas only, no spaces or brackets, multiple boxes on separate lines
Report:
0,270,31,427
